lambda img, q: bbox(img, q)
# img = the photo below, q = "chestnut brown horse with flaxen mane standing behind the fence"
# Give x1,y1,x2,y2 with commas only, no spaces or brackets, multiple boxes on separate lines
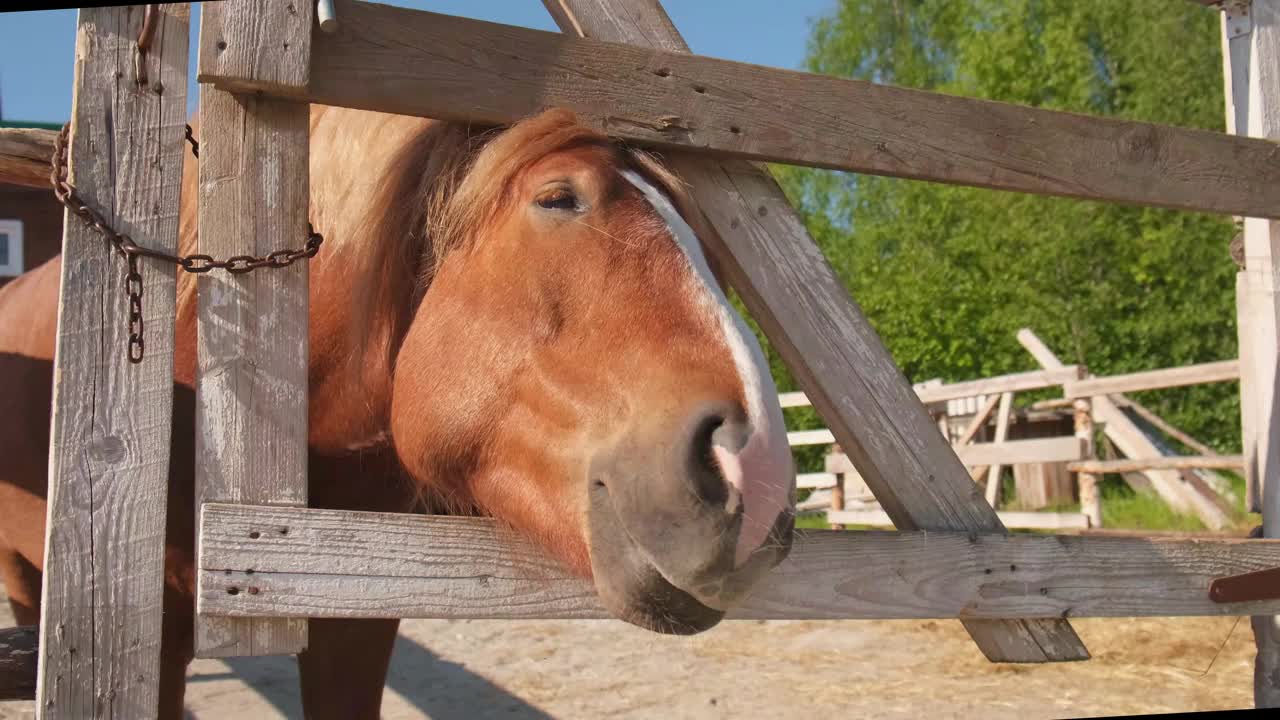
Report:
0,106,795,719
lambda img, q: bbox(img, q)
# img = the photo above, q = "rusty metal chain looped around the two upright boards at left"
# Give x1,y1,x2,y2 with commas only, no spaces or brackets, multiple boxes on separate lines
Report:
49,123,324,364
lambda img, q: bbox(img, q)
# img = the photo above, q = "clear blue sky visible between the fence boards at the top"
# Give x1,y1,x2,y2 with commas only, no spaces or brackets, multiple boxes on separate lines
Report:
0,0,836,123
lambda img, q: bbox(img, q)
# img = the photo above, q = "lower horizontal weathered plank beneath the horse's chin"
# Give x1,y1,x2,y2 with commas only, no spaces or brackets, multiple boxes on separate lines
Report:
198,505,1280,619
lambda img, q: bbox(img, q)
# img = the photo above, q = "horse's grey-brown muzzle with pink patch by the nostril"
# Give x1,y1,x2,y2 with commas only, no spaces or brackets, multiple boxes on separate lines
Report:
588,406,795,634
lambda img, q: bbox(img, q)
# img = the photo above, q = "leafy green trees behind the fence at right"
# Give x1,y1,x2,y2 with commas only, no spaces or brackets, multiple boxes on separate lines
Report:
757,0,1239,451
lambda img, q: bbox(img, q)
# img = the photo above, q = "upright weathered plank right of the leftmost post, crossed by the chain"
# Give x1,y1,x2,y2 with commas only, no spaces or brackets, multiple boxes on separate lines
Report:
196,0,314,657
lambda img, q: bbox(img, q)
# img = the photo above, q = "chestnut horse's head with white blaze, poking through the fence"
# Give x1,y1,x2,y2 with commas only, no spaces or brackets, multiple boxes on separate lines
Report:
350,110,795,633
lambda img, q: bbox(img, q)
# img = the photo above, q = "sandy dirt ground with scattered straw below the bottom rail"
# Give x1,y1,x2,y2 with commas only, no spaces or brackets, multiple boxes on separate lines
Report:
0,591,1253,720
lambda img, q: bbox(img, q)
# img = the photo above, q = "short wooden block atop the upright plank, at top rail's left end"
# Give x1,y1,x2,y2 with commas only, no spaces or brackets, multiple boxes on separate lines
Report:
197,0,315,92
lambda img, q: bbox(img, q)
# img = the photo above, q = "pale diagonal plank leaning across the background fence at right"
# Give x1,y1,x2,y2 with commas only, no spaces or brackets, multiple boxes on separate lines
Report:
1018,328,1230,530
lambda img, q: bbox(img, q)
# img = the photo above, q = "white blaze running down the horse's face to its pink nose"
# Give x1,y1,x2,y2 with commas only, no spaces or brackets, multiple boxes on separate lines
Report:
622,170,795,566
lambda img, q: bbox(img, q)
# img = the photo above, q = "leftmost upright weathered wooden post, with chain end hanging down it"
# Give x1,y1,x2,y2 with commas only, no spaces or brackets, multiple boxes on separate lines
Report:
37,4,189,720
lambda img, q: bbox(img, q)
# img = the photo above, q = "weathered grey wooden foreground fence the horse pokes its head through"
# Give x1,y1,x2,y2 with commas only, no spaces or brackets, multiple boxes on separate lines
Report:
7,0,1280,717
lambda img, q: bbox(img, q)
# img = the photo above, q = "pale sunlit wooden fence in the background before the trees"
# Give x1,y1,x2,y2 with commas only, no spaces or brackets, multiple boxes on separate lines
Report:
780,329,1244,530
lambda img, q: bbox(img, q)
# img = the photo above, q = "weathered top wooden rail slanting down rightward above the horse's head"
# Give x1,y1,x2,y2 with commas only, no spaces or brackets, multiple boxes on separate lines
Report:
200,0,1280,218
